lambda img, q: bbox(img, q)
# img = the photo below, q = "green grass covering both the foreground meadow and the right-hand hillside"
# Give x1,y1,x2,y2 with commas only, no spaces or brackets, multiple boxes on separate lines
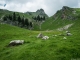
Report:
0,8,80,60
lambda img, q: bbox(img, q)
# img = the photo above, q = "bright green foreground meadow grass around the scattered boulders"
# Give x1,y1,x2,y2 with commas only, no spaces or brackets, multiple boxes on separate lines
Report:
0,24,80,60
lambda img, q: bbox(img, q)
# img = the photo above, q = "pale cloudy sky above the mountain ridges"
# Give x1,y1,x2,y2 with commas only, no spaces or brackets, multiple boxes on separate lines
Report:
0,0,80,16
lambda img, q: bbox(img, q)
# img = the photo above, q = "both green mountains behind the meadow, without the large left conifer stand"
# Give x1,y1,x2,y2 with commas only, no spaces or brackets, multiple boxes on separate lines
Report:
0,6,80,30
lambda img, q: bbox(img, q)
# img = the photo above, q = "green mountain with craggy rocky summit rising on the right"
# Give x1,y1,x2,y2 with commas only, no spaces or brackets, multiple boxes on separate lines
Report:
42,6,80,30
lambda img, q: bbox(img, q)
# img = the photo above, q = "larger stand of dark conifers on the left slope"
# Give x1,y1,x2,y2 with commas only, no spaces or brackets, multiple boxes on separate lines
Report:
3,12,33,28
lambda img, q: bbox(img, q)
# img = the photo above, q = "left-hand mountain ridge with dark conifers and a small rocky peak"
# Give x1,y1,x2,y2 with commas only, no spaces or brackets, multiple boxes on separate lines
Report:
0,9,48,30
